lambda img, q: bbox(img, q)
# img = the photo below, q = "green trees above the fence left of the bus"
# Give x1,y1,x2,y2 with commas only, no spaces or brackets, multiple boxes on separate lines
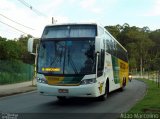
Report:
0,35,34,64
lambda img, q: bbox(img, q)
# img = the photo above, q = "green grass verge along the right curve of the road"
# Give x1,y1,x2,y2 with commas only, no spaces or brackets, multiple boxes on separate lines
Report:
128,79,160,113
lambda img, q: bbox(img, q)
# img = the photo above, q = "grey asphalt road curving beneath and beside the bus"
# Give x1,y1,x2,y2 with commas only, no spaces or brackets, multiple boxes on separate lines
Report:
0,80,146,119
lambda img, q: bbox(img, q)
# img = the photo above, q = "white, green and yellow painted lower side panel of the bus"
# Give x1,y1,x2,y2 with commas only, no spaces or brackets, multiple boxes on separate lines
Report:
104,53,128,91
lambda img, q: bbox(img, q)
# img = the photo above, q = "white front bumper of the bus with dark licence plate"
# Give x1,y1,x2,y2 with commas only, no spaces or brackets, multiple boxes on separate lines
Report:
37,82,100,97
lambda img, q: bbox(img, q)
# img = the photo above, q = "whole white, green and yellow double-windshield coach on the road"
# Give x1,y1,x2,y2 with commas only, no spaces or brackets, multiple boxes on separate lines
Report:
28,23,128,100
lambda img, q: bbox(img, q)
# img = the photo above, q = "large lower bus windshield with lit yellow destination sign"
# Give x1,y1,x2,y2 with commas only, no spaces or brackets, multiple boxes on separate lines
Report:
37,38,95,75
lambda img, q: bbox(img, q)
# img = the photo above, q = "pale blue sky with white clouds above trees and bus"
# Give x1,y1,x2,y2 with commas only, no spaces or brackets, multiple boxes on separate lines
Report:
0,0,160,39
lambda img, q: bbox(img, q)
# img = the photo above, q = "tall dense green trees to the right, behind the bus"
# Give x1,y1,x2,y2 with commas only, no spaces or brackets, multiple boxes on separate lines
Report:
105,23,160,70
